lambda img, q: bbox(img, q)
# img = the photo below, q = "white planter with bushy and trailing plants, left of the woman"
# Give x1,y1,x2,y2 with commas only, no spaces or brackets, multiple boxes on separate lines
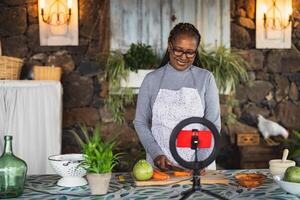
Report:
97,43,159,124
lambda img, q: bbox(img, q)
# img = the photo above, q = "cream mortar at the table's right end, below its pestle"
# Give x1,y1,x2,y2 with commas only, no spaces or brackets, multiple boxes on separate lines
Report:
269,159,296,176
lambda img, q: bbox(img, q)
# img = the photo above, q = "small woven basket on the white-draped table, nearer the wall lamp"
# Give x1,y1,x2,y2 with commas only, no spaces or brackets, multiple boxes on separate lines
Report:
33,66,61,81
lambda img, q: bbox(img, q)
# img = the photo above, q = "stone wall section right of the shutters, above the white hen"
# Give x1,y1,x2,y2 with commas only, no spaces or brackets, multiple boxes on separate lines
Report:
231,0,300,134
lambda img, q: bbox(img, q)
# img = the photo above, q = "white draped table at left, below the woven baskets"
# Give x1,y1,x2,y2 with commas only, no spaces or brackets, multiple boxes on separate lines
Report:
0,80,62,174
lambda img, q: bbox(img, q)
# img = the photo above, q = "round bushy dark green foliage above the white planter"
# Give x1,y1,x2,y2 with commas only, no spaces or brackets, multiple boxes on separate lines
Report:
124,43,160,71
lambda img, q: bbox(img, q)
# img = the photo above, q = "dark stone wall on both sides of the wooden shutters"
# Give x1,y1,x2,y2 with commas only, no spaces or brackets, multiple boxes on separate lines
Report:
0,0,300,170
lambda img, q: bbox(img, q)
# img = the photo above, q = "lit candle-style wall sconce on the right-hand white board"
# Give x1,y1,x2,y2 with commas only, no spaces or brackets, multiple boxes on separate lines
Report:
261,0,294,30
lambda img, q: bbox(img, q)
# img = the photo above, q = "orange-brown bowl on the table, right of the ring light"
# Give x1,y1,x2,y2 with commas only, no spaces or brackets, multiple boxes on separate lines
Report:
234,173,266,188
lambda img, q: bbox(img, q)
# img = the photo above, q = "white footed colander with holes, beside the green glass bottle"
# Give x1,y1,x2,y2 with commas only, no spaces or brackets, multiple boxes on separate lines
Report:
48,154,87,187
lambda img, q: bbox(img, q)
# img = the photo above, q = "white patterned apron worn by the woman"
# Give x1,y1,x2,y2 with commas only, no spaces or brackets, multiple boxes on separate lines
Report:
147,66,216,170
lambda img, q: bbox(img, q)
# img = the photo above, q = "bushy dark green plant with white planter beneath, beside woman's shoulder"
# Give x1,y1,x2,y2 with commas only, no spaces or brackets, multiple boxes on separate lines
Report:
121,43,160,89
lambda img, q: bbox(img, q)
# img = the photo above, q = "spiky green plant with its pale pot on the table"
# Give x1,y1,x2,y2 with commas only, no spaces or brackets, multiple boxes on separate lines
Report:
71,125,120,195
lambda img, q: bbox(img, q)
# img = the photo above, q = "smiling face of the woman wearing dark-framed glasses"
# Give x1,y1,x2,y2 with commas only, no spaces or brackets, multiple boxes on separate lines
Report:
168,35,197,71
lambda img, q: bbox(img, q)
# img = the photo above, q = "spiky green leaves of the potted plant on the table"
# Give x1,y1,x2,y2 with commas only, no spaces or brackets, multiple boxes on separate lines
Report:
71,125,121,174
